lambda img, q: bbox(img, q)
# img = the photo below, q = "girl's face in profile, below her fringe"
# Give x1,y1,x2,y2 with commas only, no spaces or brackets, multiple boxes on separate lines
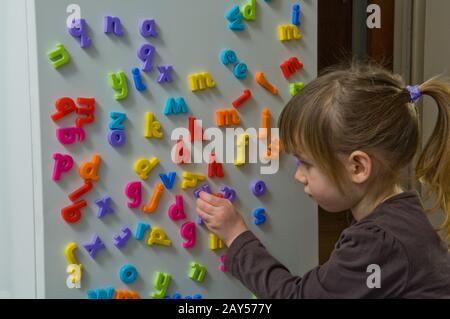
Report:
295,154,355,212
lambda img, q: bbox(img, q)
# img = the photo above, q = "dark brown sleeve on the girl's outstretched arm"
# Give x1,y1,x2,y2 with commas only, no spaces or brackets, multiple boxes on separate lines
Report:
225,224,409,299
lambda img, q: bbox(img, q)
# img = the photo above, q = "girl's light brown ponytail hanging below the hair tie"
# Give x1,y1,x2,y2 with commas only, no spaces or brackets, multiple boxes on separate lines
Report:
416,78,450,240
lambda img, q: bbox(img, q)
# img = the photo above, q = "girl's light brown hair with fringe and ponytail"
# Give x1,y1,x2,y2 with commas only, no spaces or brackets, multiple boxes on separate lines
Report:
278,62,450,238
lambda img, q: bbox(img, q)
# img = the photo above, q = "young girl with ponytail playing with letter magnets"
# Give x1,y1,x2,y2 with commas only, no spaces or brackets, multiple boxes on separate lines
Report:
197,64,450,298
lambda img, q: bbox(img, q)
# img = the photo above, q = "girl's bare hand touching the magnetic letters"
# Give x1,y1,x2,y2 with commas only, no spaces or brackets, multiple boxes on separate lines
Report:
197,192,248,247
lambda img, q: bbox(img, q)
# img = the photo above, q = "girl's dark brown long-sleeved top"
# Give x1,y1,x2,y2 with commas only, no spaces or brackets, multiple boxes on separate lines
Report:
225,191,450,298
